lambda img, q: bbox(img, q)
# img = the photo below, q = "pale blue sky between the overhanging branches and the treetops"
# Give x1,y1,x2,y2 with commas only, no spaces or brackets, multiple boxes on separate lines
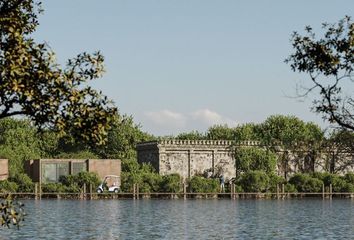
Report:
34,0,354,135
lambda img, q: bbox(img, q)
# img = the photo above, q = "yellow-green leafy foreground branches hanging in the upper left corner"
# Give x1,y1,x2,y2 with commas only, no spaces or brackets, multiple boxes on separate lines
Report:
0,0,117,144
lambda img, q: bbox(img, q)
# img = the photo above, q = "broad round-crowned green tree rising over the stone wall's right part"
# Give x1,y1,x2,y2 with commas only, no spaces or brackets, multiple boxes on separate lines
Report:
261,115,324,178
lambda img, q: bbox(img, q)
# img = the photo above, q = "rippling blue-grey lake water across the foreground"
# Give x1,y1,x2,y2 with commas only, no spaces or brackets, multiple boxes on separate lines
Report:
0,199,354,240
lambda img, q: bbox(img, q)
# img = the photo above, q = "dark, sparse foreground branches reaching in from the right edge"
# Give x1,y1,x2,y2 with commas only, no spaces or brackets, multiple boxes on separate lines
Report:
285,16,354,131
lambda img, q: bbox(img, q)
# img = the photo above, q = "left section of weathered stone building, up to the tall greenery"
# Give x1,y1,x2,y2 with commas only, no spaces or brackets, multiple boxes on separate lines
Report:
137,140,236,179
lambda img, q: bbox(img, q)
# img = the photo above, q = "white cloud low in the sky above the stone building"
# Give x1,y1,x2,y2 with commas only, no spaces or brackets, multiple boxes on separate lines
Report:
142,109,237,135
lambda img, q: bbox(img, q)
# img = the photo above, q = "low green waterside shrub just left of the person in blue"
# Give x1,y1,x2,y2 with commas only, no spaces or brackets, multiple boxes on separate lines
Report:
188,176,220,193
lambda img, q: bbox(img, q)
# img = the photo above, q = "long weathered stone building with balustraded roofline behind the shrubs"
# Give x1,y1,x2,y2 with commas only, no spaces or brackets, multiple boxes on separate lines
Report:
137,140,354,179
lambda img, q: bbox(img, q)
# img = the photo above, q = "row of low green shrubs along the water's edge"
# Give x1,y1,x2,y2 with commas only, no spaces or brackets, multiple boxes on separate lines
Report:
0,171,354,193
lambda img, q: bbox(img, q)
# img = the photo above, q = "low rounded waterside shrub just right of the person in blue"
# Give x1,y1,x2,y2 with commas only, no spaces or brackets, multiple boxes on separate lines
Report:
238,171,270,192
